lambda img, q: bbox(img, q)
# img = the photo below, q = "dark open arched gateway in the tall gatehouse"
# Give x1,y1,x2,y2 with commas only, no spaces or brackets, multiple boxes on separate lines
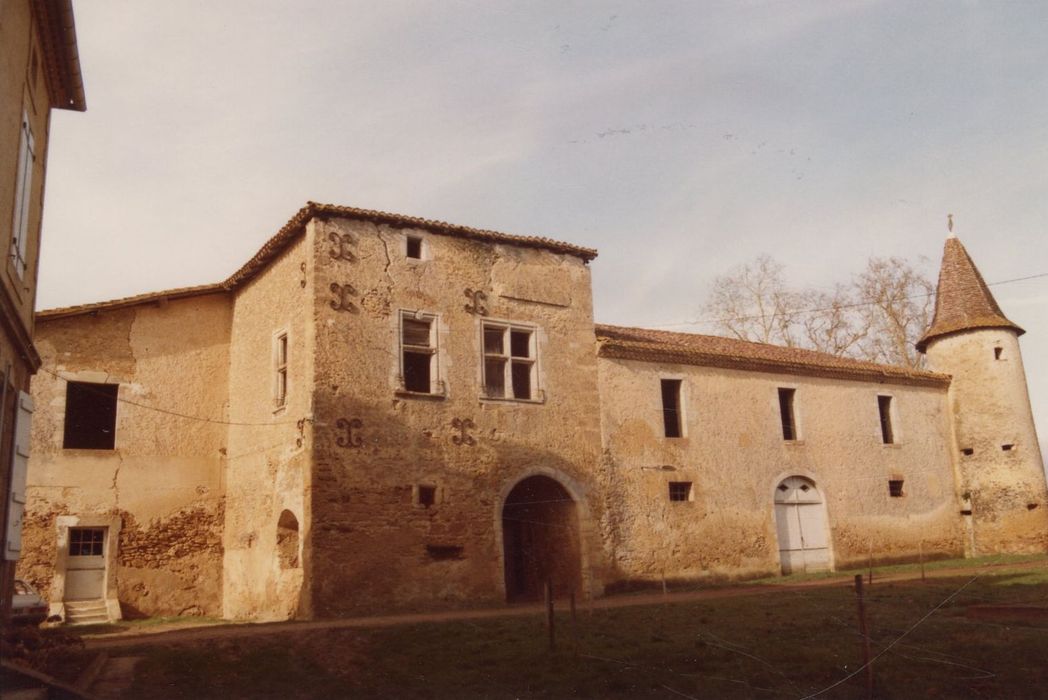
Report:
502,476,582,601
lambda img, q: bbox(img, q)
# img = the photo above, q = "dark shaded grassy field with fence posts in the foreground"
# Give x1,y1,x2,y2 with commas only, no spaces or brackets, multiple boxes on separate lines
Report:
116,567,1048,699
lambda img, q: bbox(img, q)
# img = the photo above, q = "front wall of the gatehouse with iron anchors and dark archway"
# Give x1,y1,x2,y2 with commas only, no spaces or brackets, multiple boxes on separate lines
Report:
311,220,607,615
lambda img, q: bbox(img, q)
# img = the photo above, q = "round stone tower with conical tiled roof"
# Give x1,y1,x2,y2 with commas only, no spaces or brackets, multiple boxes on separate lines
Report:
917,235,1048,555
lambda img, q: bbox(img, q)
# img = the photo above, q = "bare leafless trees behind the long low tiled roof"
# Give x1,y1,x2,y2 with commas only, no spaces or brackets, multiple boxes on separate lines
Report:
703,255,935,367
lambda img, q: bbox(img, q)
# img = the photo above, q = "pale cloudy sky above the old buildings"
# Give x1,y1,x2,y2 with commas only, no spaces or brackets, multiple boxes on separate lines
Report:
38,0,1048,461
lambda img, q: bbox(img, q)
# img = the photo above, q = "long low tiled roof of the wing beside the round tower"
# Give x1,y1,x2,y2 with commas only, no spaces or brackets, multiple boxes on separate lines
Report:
596,325,949,387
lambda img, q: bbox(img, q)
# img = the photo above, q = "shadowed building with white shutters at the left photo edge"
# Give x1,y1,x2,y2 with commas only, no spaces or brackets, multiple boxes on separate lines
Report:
0,0,86,619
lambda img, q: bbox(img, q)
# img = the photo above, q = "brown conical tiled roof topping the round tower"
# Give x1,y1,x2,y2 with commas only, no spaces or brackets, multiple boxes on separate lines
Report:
917,236,1026,352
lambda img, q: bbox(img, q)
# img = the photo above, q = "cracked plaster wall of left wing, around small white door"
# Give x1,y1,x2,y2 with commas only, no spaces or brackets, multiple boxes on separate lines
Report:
19,294,230,615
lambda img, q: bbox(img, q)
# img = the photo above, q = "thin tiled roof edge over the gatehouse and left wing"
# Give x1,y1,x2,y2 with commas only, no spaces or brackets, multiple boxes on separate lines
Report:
37,202,596,319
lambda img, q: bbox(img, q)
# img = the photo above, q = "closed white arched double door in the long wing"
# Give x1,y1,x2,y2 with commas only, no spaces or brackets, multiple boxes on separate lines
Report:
776,477,830,573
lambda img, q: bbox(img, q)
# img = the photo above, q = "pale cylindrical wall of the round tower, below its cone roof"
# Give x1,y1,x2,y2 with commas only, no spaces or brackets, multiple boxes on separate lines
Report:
927,329,1048,554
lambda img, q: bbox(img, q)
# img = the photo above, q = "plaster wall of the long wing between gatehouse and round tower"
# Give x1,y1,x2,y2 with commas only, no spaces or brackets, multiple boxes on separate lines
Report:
597,357,963,582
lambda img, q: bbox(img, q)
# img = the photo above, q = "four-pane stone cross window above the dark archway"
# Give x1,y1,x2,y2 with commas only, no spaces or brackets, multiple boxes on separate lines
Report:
483,323,538,400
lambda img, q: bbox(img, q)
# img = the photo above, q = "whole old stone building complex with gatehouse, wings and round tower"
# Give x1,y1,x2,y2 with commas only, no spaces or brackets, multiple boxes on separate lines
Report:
10,203,1048,621
